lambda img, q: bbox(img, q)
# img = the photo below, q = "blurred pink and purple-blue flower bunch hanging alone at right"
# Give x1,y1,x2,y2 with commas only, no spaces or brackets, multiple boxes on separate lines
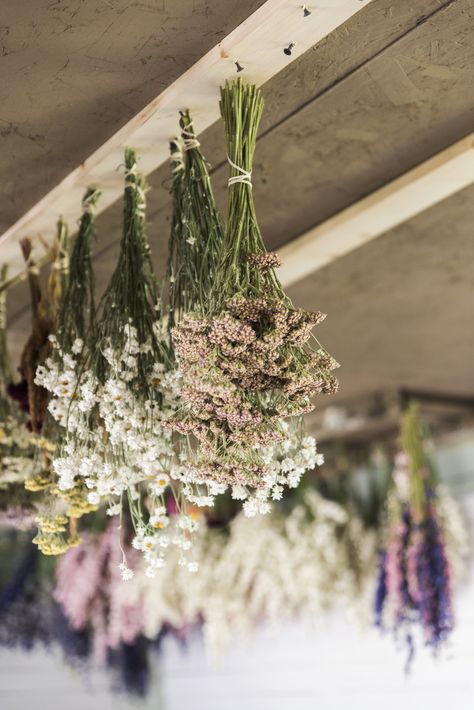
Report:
375,405,466,662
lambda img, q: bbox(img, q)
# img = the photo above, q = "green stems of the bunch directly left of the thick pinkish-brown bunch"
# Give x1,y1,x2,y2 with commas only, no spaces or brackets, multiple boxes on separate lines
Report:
167,111,224,327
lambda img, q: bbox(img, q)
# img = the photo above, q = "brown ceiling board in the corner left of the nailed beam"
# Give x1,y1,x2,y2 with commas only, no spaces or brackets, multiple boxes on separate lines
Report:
0,0,264,233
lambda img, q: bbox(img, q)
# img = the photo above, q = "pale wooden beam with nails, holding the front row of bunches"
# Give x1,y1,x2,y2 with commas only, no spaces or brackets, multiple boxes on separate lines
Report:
0,0,372,275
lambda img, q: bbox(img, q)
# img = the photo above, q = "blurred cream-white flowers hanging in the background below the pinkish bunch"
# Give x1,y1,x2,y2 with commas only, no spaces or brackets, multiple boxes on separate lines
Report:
117,491,377,659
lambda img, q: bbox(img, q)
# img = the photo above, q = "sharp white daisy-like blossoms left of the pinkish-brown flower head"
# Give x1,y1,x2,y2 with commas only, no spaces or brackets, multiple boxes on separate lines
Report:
35,325,196,579
